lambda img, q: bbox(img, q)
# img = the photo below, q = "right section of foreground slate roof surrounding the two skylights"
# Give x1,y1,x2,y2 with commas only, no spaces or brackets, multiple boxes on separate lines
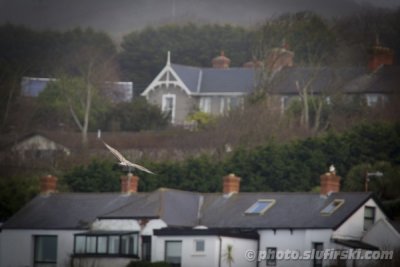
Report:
201,192,372,229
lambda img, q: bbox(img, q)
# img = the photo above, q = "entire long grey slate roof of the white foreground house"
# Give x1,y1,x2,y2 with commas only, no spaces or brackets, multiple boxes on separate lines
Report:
3,188,372,229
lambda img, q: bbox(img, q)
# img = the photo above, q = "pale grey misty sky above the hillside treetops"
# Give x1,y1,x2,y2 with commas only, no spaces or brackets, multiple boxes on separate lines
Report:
0,0,400,38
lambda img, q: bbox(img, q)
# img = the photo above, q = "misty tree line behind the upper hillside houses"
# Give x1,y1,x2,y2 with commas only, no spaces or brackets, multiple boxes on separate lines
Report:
0,9,400,134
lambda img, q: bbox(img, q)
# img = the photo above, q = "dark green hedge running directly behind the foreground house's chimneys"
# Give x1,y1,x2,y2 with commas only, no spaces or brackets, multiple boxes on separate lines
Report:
0,123,400,221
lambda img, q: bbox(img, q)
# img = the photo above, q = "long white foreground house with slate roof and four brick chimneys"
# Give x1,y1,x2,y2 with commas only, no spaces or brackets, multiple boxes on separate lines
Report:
0,171,400,267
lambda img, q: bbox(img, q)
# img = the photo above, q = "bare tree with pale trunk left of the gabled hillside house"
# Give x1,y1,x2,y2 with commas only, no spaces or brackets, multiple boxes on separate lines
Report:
40,47,118,147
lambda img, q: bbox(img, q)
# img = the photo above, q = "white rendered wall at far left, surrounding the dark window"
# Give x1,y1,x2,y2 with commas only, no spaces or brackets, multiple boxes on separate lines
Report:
0,229,79,267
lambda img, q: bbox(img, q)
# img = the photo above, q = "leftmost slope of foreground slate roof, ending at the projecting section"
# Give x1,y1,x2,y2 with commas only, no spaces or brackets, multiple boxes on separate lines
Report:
3,193,139,229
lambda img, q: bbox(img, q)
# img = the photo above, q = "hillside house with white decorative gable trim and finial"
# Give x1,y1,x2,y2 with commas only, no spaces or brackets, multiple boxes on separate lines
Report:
142,53,256,124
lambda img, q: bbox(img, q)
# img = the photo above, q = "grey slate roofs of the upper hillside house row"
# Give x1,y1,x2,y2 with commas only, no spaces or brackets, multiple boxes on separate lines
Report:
167,64,400,97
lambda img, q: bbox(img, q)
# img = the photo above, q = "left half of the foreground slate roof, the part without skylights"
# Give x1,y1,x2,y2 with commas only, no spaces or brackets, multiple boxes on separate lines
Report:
3,189,201,229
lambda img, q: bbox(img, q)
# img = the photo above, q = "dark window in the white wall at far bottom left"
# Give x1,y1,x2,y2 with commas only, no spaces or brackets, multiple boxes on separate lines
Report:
33,235,57,267
